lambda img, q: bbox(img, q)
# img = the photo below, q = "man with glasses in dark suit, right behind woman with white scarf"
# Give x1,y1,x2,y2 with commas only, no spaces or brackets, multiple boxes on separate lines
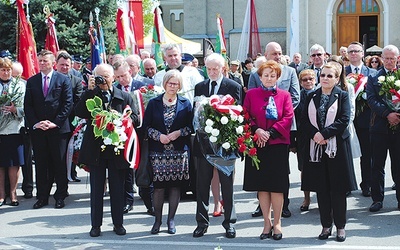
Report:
345,42,376,197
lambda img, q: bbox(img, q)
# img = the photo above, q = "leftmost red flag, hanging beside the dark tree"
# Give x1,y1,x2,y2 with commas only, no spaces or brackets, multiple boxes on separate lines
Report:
17,0,39,79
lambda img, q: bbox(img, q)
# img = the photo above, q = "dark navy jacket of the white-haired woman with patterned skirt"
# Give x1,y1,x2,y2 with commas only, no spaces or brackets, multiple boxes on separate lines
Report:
143,94,193,152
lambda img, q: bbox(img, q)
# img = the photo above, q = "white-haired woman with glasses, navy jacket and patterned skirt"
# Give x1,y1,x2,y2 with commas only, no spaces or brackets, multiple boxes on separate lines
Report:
144,70,192,234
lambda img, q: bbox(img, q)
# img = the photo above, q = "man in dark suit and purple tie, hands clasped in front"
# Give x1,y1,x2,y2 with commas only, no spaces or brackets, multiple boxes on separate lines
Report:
24,50,73,209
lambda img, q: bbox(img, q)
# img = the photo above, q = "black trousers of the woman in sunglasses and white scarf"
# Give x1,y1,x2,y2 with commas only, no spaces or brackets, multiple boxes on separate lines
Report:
317,191,347,229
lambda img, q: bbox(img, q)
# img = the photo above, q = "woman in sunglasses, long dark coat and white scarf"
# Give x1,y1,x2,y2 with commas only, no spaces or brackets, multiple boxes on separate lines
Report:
301,62,357,242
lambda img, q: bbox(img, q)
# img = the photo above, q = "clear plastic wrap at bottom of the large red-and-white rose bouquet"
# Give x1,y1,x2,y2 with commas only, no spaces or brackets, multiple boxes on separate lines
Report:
196,131,239,176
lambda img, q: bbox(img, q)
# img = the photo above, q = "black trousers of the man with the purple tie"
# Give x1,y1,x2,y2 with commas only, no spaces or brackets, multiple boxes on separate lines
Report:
31,130,68,201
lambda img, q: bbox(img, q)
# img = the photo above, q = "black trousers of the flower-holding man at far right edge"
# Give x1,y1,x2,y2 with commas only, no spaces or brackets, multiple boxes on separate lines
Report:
370,133,400,202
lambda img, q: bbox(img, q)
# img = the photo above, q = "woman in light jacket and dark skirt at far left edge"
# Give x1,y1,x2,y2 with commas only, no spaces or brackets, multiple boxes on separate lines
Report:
0,58,25,206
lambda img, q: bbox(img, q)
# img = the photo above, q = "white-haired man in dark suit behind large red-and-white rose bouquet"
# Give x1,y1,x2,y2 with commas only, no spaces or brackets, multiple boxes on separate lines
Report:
193,53,242,238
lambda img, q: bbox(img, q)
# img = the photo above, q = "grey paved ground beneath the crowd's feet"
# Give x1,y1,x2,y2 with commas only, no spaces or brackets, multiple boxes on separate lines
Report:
0,154,400,250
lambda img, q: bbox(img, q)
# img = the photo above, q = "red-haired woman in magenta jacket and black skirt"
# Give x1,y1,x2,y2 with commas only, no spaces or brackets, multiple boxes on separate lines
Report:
243,60,293,240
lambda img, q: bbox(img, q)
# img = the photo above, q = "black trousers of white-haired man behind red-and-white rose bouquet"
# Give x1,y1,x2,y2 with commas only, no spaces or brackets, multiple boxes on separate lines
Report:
196,156,237,229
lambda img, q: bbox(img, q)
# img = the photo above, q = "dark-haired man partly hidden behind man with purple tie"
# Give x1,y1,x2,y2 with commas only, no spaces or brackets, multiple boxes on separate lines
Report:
56,51,83,182
